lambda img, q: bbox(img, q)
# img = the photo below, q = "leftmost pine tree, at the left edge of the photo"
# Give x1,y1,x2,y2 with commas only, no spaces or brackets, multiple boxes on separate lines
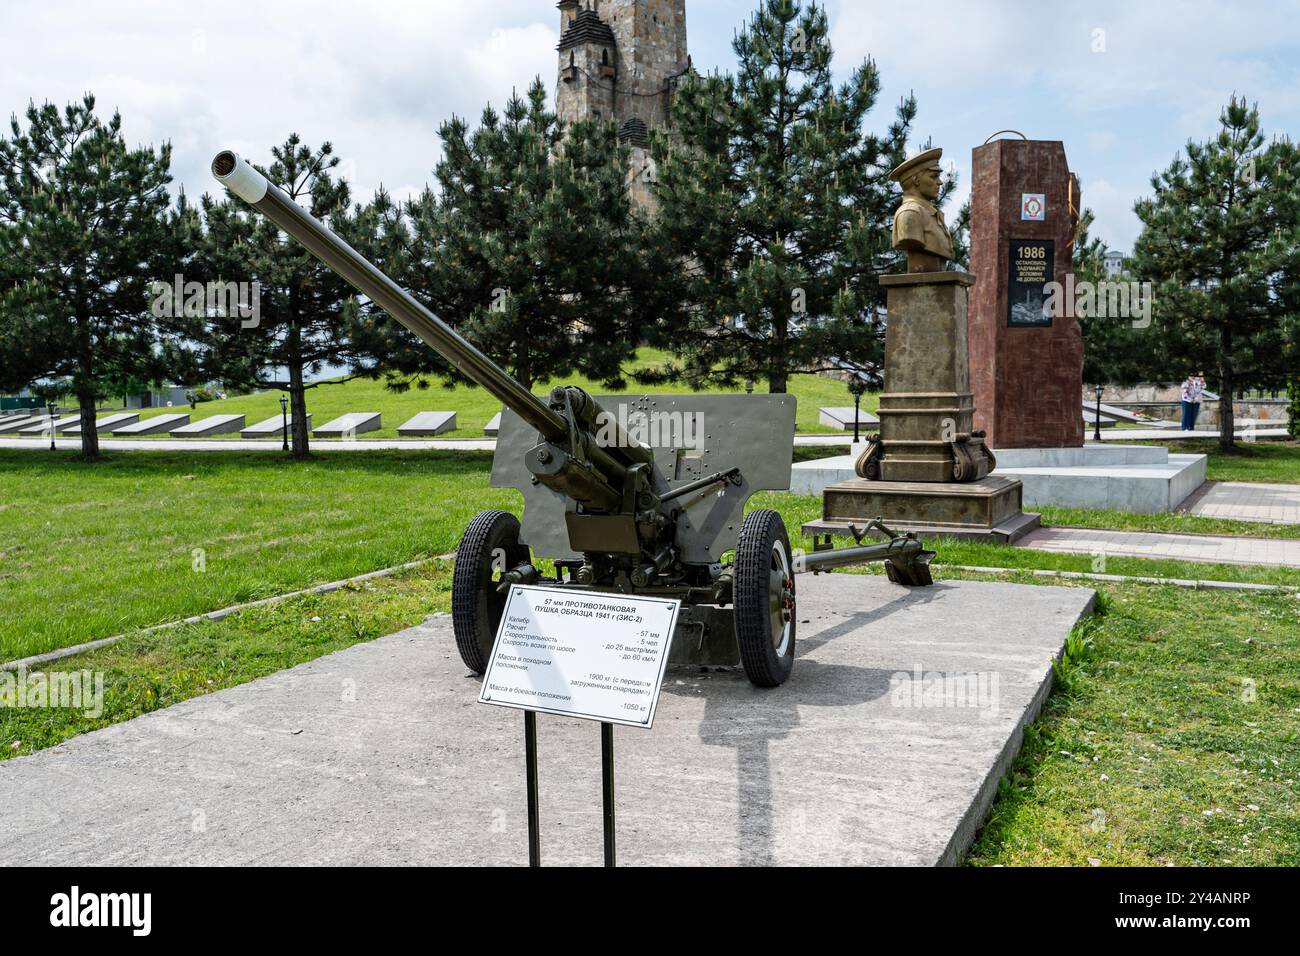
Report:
0,94,191,460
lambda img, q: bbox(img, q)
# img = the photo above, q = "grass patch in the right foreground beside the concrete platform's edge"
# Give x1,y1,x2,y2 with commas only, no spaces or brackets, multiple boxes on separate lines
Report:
967,585,1300,866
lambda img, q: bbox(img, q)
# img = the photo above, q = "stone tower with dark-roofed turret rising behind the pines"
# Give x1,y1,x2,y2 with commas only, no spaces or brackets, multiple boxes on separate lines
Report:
555,0,690,208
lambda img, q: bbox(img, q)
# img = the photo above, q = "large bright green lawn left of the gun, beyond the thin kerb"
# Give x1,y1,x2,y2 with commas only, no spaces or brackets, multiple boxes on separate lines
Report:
0,450,520,661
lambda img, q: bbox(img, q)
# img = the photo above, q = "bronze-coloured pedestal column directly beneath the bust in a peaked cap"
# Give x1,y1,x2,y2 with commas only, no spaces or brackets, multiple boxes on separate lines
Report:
878,272,993,483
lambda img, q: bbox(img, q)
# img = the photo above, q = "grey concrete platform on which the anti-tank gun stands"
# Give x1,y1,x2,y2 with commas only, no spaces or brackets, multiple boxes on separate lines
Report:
0,575,1095,866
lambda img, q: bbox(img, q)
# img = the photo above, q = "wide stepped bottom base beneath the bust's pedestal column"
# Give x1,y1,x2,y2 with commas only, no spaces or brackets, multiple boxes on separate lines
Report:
803,475,1039,544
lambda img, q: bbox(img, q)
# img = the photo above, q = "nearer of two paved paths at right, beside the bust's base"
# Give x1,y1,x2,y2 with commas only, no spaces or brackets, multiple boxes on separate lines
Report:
1018,528,1300,567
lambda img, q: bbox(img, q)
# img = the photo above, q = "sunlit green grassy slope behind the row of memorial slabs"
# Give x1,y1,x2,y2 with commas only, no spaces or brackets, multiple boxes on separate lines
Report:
61,349,880,444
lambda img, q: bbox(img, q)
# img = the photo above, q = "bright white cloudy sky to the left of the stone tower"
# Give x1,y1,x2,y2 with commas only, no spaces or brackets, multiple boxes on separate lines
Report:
0,0,559,195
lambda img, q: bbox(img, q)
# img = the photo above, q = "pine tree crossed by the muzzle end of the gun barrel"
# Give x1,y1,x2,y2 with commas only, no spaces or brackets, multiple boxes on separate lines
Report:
196,133,369,458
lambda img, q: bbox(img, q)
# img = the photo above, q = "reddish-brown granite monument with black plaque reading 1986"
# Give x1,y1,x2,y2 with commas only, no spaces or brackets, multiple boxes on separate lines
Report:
967,139,1083,449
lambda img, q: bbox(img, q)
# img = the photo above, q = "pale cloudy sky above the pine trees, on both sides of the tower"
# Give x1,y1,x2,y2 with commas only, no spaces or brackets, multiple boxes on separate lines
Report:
0,0,1300,251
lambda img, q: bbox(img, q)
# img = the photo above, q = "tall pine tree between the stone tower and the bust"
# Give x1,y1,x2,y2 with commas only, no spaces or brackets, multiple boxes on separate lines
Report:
644,0,917,392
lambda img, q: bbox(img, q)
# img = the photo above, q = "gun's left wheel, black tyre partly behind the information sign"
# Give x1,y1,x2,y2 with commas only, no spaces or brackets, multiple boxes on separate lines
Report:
451,511,530,674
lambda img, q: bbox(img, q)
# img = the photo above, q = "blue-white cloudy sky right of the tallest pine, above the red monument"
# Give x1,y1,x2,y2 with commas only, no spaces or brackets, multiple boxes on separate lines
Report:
832,0,1300,248
